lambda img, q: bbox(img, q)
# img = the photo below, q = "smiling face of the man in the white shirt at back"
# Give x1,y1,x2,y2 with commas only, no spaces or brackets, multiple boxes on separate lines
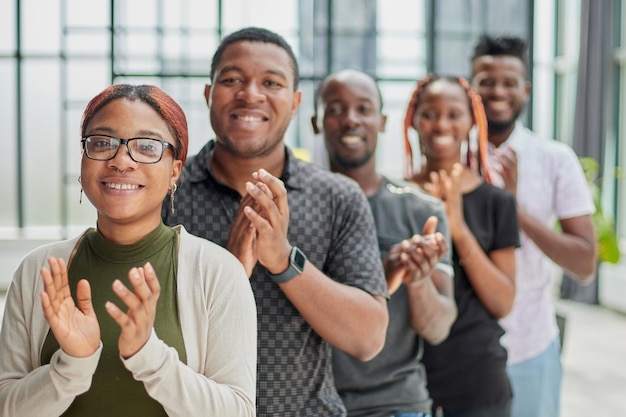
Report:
472,55,530,136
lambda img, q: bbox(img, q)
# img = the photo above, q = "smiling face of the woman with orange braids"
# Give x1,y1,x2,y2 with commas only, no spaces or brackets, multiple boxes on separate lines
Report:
413,79,474,162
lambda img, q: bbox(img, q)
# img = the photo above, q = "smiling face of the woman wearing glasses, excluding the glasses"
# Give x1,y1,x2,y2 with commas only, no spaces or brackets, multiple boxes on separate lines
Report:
81,98,182,237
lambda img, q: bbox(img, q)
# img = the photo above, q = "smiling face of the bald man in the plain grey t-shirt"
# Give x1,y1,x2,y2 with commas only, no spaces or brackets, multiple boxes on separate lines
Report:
312,70,386,169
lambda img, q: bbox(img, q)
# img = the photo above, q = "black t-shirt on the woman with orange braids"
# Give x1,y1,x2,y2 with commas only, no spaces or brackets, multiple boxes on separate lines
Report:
422,183,519,409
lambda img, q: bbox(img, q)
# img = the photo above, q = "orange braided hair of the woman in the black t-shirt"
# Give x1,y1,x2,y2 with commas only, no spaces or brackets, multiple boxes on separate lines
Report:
404,74,492,183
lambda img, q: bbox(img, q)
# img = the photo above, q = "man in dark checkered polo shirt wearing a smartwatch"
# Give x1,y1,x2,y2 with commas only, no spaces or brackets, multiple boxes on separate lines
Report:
163,28,388,417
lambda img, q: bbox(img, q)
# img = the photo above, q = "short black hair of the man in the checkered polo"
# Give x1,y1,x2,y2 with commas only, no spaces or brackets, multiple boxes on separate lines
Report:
209,26,300,90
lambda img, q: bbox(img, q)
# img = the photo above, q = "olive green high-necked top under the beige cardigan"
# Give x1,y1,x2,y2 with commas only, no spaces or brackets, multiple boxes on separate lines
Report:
41,224,186,417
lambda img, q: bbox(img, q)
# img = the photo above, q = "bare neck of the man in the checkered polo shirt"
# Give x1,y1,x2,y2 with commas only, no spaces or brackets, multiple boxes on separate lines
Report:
211,143,286,196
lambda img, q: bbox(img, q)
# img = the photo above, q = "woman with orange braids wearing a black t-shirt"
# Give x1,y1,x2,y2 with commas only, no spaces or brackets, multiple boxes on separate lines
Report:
404,75,519,417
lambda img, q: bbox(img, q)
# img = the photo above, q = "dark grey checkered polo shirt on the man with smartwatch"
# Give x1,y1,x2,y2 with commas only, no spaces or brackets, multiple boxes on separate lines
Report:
163,141,386,417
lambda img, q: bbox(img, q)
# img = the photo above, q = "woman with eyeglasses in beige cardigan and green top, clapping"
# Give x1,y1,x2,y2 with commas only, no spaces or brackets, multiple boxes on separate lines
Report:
0,85,257,417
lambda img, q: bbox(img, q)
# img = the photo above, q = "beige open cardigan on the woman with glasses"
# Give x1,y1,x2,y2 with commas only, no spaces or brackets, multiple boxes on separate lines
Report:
0,226,257,417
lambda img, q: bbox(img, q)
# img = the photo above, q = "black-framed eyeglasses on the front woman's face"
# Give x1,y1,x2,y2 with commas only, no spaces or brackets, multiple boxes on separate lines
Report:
80,135,176,164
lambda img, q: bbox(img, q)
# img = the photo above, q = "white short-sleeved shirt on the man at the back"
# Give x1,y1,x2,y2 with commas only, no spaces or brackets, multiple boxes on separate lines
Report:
492,122,595,364
